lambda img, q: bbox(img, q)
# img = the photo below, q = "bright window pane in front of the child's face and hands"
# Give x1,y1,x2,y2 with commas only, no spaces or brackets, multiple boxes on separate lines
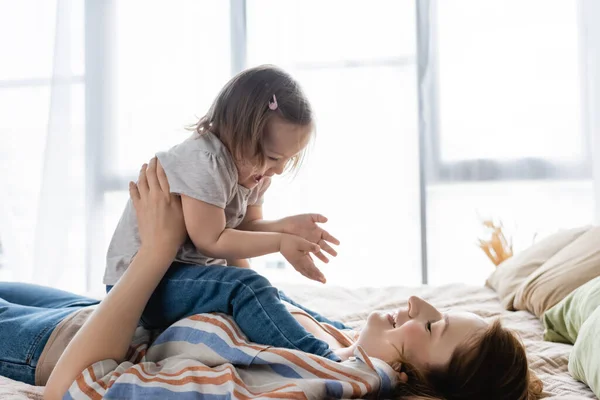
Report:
247,0,421,286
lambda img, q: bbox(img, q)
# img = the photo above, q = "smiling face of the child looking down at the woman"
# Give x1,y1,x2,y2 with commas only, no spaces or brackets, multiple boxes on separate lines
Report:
236,117,313,189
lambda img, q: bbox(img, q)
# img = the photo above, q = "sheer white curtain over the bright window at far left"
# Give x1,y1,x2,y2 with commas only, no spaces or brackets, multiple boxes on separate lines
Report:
0,0,85,290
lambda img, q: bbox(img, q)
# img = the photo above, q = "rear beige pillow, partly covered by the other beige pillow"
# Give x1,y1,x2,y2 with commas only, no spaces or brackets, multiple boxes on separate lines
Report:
486,226,590,310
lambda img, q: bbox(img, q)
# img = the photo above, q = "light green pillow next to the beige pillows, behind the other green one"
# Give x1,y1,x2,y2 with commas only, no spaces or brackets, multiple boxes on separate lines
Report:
543,276,600,344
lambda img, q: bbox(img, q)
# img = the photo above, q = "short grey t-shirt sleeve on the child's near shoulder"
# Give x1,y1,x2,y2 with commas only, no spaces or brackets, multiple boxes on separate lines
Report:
156,139,236,209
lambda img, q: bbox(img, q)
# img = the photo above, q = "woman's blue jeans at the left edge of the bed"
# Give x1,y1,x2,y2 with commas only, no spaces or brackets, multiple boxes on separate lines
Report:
0,282,99,385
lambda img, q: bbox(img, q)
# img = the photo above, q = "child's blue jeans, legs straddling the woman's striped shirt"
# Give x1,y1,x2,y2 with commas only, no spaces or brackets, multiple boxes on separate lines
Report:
107,263,343,361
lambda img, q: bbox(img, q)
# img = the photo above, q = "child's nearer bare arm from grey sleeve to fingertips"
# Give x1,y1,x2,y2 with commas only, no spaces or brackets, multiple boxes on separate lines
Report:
181,195,325,282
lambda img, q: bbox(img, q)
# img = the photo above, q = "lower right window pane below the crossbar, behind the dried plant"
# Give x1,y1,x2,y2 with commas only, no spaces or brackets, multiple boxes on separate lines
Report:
427,181,594,285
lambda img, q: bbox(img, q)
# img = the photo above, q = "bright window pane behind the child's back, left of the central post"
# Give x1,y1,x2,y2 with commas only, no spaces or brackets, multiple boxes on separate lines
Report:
88,0,231,290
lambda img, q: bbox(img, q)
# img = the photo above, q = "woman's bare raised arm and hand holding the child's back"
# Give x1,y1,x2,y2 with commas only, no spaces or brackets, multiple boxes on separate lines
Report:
44,158,185,400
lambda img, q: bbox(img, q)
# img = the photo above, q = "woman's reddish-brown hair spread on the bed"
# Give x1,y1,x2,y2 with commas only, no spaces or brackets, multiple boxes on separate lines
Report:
396,320,542,400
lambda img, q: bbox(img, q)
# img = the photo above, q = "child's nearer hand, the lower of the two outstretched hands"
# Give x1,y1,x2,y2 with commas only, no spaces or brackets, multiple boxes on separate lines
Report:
279,234,325,283
